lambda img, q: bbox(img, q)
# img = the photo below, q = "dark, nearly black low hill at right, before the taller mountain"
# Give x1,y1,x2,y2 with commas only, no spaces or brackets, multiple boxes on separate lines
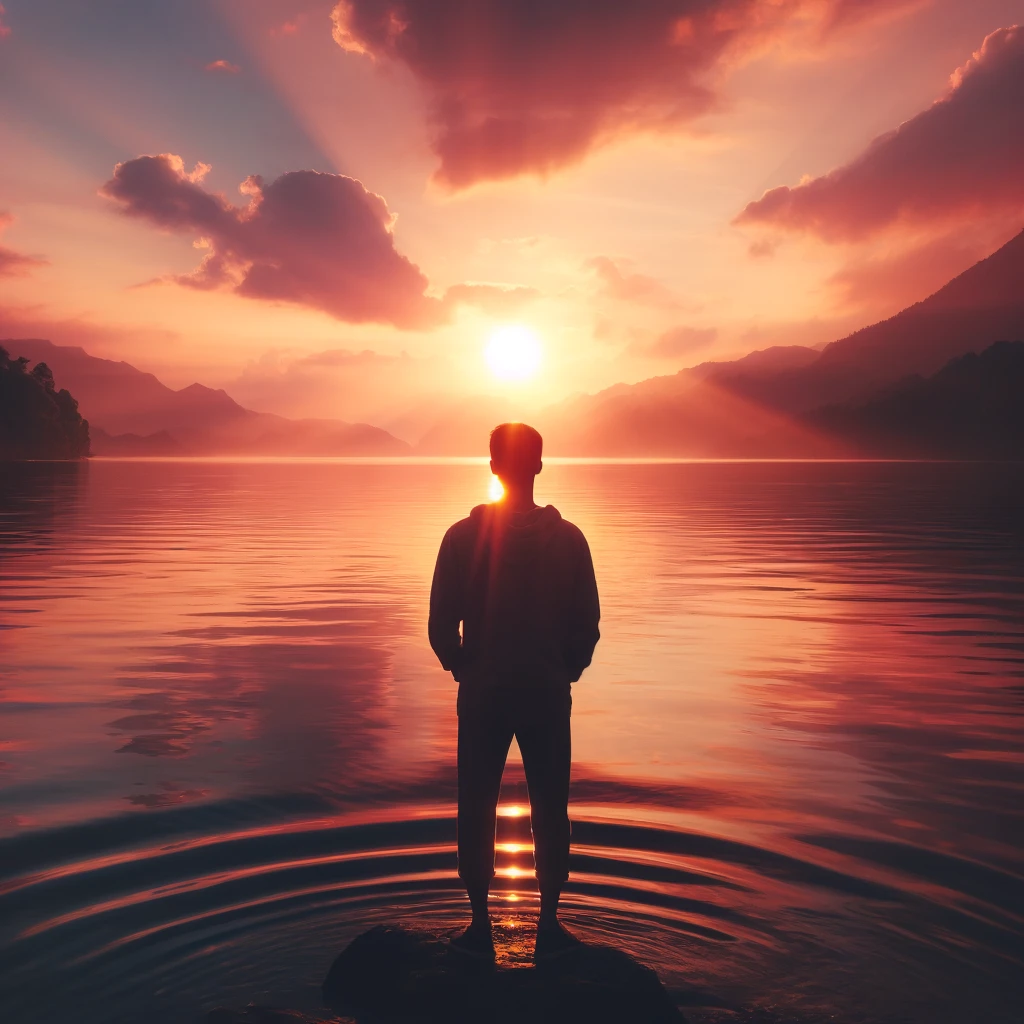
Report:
808,341,1024,459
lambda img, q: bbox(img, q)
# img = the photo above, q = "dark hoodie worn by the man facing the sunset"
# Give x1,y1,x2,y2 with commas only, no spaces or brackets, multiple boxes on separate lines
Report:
428,504,601,690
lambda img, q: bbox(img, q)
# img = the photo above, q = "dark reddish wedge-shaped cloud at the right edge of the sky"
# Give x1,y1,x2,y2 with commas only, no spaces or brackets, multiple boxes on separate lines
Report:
736,26,1024,242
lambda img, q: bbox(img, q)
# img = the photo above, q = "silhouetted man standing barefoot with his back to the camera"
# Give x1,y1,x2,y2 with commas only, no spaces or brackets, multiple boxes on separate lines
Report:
428,423,600,961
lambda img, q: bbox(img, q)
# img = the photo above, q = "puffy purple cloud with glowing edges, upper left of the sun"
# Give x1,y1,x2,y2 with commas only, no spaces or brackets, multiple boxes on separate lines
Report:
100,154,447,329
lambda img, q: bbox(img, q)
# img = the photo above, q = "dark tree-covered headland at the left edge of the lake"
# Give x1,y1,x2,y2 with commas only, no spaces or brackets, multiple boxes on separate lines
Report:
0,346,89,460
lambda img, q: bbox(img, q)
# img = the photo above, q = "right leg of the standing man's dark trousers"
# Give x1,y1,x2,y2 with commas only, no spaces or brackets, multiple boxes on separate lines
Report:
516,693,572,894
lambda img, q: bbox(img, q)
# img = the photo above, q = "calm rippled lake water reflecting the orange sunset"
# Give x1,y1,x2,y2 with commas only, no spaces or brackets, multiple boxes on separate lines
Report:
0,461,1024,1024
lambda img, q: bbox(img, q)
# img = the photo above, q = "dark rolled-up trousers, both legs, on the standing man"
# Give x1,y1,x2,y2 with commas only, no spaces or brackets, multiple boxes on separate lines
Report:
459,684,572,888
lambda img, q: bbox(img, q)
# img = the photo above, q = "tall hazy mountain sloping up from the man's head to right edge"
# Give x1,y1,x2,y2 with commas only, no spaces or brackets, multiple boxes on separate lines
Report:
538,231,1024,458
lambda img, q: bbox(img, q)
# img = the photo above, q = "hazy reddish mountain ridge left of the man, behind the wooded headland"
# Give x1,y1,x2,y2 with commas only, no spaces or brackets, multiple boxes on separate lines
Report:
5,338,410,456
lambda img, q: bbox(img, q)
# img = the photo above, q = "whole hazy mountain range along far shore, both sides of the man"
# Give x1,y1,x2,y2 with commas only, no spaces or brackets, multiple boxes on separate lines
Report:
0,231,1024,458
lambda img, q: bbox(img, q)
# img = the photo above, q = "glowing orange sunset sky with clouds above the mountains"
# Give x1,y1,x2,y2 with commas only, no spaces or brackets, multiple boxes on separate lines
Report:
0,0,1024,425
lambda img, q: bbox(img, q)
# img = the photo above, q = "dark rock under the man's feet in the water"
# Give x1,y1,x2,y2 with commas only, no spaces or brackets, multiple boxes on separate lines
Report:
319,926,684,1024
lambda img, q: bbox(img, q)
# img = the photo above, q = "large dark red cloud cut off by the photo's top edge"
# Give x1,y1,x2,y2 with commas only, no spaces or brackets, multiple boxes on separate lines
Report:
334,0,919,188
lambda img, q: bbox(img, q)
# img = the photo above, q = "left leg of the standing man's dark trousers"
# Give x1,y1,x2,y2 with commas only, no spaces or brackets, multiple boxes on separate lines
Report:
458,692,513,889
